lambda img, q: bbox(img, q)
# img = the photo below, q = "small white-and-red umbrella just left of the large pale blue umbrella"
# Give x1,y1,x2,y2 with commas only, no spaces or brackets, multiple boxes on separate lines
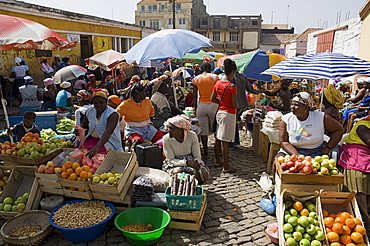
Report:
87,50,124,71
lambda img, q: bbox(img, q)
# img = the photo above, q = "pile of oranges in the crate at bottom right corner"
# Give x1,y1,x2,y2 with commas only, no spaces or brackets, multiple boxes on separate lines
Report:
323,210,366,246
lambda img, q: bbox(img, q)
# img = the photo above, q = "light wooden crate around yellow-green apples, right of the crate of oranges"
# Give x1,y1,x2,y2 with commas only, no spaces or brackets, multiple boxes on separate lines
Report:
89,151,139,203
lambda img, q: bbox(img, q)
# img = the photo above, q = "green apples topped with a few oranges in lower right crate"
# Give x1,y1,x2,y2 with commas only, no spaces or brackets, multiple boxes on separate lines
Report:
283,201,325,246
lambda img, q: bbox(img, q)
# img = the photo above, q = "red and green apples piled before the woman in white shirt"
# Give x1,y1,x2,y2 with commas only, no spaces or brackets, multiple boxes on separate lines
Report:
278,155,339,175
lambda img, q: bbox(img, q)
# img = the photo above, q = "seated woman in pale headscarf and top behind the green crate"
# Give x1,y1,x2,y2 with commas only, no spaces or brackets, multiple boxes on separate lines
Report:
163,115,209,184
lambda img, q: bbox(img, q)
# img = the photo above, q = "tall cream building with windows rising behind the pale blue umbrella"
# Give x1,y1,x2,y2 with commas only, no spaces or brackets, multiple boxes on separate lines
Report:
135,0,193,30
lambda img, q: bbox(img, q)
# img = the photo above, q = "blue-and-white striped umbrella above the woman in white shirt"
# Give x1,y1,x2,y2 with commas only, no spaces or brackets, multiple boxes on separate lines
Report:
261,52,370,80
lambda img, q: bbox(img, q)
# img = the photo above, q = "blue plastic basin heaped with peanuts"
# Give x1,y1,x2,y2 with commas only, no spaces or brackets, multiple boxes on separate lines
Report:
49,200,115,243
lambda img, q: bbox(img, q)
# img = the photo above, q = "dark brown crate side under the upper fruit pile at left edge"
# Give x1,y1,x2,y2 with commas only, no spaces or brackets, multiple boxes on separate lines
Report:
0,149,63,166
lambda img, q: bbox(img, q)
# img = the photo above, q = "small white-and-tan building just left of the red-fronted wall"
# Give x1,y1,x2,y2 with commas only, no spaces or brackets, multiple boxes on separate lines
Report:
281,28,321,58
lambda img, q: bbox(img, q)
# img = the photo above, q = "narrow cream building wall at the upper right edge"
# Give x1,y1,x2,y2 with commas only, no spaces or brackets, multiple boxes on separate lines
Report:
358,0,370,61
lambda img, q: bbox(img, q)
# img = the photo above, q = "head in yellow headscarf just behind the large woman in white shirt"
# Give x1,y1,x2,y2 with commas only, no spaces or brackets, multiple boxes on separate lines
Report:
323,85,344,122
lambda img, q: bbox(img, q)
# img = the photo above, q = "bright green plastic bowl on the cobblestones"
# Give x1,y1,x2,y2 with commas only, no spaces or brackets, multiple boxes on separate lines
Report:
114,207,171,246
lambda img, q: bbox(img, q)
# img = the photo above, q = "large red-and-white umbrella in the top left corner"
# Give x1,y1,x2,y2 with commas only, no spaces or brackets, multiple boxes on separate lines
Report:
0,14,77,50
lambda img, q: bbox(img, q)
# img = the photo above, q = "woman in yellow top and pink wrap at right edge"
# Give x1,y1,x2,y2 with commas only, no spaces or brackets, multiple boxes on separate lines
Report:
338,114,370,231
